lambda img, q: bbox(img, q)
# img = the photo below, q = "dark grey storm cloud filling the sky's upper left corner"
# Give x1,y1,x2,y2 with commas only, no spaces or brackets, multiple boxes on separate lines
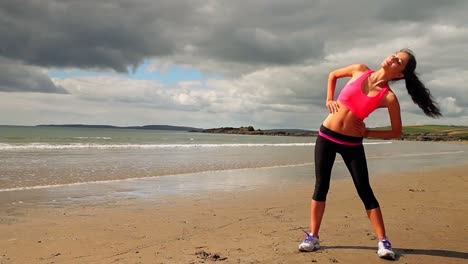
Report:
0,0,181,71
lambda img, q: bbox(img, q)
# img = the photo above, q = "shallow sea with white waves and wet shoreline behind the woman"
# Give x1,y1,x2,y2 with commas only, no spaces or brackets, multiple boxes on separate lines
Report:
0,126,468,205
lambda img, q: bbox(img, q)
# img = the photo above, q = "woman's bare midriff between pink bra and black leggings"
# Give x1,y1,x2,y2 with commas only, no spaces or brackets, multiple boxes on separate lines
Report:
323,102,363,137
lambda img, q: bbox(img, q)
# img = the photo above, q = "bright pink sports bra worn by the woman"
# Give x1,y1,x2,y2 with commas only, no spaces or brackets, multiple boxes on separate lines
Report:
338,70,390,120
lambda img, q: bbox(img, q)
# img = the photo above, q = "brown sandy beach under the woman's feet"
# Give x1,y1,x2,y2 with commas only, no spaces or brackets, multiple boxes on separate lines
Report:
0,165,468,264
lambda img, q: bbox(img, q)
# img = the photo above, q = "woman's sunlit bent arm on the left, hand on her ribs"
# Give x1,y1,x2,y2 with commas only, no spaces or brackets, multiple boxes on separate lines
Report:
325,64,369,113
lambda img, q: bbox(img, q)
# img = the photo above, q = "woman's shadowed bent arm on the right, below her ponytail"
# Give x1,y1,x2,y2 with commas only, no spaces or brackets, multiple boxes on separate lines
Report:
364,92,403,139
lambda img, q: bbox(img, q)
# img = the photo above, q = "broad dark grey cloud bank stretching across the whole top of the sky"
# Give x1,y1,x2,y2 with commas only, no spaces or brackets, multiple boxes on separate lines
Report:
0,0,467,72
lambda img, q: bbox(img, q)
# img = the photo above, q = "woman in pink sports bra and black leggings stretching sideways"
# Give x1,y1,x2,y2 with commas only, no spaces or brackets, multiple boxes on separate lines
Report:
299,49,441,259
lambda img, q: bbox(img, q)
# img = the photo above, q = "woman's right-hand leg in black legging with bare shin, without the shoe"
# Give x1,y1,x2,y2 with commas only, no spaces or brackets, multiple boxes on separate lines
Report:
340,146,386,239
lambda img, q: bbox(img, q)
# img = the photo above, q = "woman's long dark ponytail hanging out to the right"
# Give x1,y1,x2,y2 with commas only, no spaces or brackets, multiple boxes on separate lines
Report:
400,49,442,118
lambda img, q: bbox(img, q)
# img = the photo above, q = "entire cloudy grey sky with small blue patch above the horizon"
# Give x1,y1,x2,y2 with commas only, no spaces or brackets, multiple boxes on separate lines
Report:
0,0,468,129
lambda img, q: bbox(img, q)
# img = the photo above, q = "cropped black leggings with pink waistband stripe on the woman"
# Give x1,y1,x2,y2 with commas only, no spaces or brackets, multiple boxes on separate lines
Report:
312,126,379,210
